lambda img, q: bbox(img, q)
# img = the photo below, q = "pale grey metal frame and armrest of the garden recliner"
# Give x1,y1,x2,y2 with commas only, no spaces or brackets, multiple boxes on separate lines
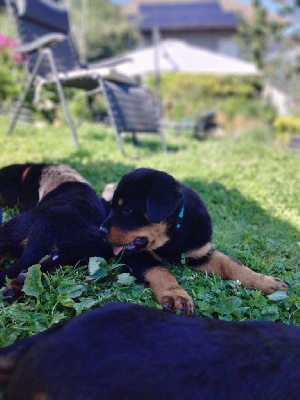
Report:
5,0,167,158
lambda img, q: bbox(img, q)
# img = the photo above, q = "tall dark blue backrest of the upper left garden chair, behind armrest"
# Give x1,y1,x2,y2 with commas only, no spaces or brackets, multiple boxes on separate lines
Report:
5,0,79,77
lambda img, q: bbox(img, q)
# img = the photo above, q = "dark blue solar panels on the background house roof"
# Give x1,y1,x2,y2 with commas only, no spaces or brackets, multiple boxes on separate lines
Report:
139,2,238,30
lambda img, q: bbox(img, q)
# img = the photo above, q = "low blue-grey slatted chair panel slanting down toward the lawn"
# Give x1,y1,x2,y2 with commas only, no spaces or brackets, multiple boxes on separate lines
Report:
102,80,160,133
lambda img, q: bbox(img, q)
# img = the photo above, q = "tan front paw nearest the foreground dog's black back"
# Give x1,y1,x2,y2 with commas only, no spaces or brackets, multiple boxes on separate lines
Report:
158,287,195,315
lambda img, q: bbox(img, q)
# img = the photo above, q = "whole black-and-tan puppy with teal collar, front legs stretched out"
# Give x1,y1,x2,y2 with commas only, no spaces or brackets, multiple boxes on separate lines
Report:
100,168,288,314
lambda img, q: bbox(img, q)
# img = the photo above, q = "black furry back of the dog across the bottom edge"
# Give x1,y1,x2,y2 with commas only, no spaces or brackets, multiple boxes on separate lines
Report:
0,303,300,400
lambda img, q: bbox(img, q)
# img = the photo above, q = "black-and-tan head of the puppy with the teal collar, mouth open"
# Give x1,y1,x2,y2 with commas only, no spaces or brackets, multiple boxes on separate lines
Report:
100,168,183,254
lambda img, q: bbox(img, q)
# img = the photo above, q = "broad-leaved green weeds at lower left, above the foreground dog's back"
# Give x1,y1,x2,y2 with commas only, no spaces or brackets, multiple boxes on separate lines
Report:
0,264,149,346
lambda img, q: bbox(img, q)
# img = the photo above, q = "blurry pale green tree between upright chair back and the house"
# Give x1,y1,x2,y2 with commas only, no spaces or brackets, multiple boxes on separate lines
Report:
68,0,138,61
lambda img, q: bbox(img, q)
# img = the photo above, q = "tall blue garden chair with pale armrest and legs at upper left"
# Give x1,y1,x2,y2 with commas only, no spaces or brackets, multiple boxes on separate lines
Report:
5,0,166,156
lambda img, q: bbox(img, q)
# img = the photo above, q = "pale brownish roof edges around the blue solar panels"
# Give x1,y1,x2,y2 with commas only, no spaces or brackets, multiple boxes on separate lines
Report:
122,0,287,23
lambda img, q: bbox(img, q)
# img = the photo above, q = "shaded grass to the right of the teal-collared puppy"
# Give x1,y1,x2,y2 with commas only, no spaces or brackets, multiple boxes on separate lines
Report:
183,178,300,294
